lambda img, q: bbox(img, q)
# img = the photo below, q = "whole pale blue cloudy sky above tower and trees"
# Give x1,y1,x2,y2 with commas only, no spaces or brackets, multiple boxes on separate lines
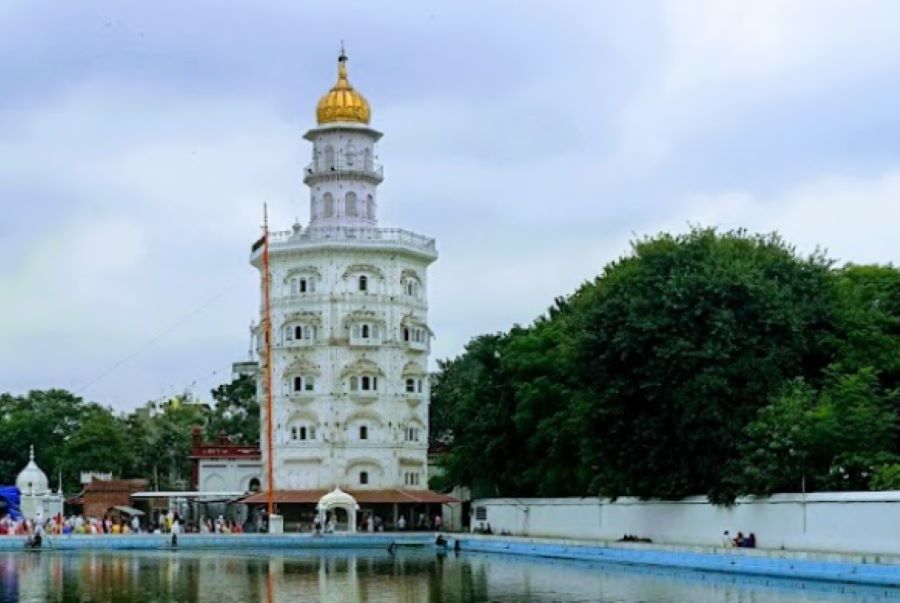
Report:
0,0,900,409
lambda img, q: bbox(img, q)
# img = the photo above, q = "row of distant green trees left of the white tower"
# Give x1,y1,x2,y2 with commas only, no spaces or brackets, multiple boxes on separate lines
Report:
0,376,259,491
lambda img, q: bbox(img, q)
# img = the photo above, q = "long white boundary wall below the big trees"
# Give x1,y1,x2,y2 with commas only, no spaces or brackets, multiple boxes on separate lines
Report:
471,491,900,554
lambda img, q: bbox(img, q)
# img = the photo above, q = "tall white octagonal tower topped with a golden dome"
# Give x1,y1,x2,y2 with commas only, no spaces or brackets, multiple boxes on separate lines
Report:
251,52,437,491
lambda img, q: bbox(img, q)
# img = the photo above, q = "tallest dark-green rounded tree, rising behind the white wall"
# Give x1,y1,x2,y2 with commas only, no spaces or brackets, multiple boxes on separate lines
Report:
573,229,835,500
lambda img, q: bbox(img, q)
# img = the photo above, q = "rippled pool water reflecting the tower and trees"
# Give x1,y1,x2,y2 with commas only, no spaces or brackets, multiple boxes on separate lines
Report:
0,550,900,603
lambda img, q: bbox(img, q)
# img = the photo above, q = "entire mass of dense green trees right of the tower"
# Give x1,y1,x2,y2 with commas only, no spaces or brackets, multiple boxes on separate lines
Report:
432,228,900,503
